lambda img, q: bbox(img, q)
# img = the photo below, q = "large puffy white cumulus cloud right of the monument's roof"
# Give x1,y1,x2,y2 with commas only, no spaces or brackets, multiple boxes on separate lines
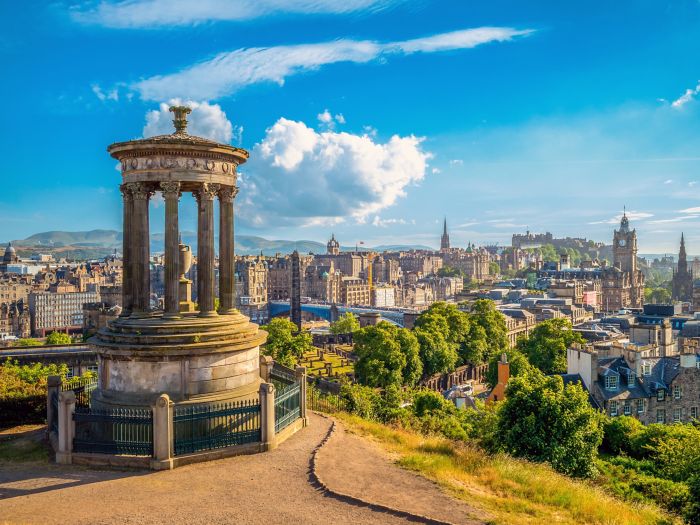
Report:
239,118,431,225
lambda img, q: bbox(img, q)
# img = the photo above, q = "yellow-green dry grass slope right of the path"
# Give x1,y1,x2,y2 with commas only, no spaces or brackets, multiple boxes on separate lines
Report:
338,414,680,525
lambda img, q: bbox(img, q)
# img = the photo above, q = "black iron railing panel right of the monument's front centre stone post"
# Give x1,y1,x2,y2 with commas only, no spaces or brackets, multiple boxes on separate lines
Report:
173,399,261,456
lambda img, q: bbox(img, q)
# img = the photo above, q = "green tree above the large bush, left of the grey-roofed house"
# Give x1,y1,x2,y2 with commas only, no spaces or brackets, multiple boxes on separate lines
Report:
517,318,585,375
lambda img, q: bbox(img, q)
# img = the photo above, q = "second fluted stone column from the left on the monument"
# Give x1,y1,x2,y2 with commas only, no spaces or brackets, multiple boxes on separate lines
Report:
129,182,153,317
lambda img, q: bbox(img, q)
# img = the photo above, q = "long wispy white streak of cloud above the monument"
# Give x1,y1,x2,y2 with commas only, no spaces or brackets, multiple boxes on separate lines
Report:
130,27,531,100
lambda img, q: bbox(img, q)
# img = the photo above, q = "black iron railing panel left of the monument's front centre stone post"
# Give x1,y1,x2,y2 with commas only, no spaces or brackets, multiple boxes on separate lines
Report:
73,406,153,456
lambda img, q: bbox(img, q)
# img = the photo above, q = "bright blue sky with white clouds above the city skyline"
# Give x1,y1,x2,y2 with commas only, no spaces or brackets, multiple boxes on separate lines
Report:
0,0,700,253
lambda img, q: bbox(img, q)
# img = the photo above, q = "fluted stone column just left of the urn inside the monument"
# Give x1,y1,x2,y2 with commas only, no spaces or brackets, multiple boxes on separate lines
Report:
160,182,180,319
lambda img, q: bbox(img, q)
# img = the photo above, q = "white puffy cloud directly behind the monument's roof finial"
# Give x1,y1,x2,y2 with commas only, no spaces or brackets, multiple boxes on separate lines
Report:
143,99,235,144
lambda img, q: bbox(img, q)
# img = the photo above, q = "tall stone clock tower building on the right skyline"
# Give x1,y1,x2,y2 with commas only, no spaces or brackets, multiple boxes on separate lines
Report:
600,213,644,312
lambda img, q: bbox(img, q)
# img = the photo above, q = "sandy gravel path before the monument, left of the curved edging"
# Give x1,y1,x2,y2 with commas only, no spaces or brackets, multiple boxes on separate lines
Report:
0,414,482,525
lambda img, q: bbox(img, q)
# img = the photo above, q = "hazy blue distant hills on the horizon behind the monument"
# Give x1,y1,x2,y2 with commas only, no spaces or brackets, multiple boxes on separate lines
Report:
4,230,430,259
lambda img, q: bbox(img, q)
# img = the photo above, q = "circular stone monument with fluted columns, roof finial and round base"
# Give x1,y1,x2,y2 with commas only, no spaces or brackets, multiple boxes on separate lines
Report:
90,106,267,408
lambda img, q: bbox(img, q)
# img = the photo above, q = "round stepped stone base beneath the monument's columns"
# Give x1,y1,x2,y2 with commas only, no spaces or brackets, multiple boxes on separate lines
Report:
89,312,267,408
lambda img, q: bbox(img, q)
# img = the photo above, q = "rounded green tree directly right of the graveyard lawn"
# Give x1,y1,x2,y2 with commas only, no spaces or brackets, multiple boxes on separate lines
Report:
353,321,423,387
